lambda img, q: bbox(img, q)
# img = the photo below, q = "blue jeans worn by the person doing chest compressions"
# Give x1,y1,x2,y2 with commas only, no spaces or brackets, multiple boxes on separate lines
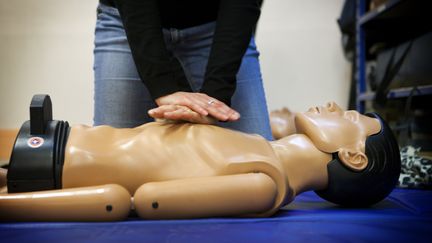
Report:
94,4,272,140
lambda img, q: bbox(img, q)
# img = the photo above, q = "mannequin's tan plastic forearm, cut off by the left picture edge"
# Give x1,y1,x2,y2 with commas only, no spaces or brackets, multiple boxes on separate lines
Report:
0,184,131,221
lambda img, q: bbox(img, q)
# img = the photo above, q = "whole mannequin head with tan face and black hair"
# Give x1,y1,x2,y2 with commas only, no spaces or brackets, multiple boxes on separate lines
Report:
296,102,400,206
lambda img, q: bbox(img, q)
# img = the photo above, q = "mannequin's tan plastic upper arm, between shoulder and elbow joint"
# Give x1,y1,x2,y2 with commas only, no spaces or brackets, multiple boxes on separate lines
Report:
134,173,277,219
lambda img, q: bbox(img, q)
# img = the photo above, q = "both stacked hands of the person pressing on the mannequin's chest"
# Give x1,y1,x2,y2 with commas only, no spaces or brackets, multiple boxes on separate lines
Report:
148,92,240,124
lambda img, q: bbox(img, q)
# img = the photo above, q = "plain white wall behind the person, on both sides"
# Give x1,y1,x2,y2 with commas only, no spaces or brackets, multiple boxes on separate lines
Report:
0,0,349,128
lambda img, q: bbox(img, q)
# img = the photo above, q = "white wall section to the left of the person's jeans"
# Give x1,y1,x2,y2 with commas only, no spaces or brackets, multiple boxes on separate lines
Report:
0,0,97,128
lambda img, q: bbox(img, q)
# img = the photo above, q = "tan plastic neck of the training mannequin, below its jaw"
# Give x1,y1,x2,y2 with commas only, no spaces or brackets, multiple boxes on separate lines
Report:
271,134,332,196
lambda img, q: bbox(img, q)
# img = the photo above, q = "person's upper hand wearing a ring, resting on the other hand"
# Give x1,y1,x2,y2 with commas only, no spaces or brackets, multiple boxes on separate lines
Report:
154,92,240,121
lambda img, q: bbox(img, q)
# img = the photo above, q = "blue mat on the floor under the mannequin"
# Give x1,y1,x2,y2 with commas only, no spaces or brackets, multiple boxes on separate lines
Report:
0,189,432,243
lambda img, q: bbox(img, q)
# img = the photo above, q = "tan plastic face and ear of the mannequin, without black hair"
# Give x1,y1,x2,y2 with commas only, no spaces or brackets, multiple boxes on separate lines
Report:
295,102,381,170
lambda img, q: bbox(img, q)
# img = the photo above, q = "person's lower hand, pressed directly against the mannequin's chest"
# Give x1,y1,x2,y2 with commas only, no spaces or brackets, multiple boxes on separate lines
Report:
148,105,216,124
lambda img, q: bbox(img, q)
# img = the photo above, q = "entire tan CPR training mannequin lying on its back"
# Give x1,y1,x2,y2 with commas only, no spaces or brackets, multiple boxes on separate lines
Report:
0,96,400,221
